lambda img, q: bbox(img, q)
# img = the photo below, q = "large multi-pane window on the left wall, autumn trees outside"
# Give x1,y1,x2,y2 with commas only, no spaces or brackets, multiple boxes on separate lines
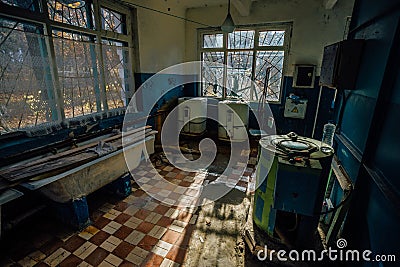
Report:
0,0,134,132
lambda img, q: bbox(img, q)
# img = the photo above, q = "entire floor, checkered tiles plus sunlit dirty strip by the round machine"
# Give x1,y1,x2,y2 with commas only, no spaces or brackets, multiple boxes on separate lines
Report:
0,141,260,266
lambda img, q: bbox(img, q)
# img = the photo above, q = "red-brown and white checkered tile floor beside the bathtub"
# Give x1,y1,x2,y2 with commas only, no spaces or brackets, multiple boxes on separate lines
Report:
3,154,254,267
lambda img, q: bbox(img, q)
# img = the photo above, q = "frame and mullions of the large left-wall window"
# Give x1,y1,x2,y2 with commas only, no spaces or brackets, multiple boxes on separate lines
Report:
0,0,140,131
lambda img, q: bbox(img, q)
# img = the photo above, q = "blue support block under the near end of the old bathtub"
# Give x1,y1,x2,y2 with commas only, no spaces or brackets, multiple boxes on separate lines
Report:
53,197,91,230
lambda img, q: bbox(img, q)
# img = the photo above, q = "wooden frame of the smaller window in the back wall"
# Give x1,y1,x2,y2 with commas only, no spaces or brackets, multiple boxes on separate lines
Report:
197,22,293,104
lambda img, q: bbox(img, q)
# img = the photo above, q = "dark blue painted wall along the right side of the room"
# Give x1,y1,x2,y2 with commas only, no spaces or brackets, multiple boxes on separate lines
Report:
336,0,400,266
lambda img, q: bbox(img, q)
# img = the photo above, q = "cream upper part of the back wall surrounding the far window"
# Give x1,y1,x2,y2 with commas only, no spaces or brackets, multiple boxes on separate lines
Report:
185,0,354,76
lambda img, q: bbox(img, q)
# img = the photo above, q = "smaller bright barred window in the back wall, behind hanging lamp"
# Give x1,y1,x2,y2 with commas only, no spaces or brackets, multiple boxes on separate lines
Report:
200,24,290,102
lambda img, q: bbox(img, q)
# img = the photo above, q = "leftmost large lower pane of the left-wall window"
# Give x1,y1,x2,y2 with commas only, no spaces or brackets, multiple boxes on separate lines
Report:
0,19,50,131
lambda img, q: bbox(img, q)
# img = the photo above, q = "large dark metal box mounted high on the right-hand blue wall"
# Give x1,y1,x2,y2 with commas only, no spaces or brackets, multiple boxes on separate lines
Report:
319,39,364,90
